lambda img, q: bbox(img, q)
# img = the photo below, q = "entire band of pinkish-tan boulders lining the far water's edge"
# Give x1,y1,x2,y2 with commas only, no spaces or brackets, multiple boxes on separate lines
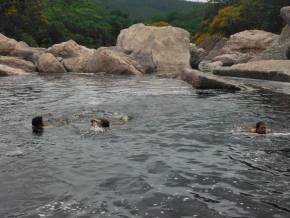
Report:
0,7,290,90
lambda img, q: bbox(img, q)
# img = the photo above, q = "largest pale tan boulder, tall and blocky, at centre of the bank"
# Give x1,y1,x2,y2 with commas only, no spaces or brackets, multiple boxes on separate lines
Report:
117,24,190,73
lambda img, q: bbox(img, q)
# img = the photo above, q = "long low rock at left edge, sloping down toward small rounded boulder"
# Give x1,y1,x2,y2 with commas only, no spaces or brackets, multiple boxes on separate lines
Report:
0,56,36,72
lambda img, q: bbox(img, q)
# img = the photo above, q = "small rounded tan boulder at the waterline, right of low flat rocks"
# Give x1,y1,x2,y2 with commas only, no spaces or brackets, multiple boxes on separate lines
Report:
37,53,66,73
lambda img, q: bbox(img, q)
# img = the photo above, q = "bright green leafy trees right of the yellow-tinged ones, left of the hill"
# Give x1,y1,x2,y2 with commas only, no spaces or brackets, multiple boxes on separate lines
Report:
45,0,131,47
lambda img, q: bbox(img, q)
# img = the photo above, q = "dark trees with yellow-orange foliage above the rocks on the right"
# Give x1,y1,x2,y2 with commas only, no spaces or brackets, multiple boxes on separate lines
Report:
195,0,290,42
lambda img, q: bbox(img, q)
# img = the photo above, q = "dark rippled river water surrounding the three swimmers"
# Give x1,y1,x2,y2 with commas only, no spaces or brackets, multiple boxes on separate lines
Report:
0,75,290,218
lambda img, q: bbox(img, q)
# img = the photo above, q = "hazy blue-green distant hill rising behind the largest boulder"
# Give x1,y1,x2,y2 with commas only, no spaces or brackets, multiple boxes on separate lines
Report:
96,0,202,20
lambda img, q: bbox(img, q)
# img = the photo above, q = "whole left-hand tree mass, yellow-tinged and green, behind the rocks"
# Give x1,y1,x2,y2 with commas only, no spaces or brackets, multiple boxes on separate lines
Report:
0,0,131,47
